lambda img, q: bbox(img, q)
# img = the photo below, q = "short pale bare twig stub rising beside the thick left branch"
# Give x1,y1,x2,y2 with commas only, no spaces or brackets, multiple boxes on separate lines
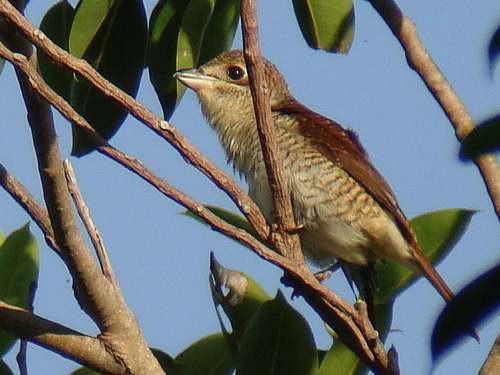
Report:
63,159,118,288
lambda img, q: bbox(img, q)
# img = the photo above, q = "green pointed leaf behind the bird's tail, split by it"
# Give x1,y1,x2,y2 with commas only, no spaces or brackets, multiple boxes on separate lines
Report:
375,208,476,304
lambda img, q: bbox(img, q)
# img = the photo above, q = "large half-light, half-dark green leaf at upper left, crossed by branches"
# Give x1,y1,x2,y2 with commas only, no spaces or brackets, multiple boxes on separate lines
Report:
69,0,147,156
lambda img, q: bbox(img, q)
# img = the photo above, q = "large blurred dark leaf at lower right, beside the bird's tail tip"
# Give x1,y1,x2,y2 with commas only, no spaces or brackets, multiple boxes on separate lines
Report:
431,264,500,362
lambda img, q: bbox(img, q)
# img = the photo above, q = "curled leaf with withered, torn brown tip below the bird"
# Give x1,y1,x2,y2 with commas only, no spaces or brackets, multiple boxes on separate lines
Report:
210,253,271,351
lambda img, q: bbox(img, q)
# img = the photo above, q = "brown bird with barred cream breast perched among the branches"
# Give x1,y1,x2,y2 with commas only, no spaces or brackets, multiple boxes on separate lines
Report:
174,50,454,318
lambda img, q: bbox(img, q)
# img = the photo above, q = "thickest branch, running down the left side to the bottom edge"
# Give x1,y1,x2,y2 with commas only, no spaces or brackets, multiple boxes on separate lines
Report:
0,13,164,374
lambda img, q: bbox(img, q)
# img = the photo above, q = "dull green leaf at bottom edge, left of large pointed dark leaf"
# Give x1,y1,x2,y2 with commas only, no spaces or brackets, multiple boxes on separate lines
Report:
168,333,234,375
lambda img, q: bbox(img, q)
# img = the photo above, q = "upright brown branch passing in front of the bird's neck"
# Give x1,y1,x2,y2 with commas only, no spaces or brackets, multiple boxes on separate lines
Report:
241,0,305,266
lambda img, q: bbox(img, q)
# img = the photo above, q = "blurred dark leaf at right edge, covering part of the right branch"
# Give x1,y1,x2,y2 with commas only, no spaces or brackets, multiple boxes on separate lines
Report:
460,114,500,160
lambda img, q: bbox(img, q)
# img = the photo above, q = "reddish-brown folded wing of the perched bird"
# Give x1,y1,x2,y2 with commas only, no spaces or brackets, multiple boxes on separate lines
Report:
272,100,415,244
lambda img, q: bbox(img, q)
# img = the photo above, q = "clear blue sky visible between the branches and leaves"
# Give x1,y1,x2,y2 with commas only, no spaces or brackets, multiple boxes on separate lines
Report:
0,0,500,375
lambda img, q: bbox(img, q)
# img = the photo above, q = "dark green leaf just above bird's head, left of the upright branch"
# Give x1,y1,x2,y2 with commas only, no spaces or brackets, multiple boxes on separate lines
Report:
197,0,240,66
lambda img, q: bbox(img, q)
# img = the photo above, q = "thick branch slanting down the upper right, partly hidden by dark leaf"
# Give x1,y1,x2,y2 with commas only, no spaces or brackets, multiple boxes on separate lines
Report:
370,0,500,219
